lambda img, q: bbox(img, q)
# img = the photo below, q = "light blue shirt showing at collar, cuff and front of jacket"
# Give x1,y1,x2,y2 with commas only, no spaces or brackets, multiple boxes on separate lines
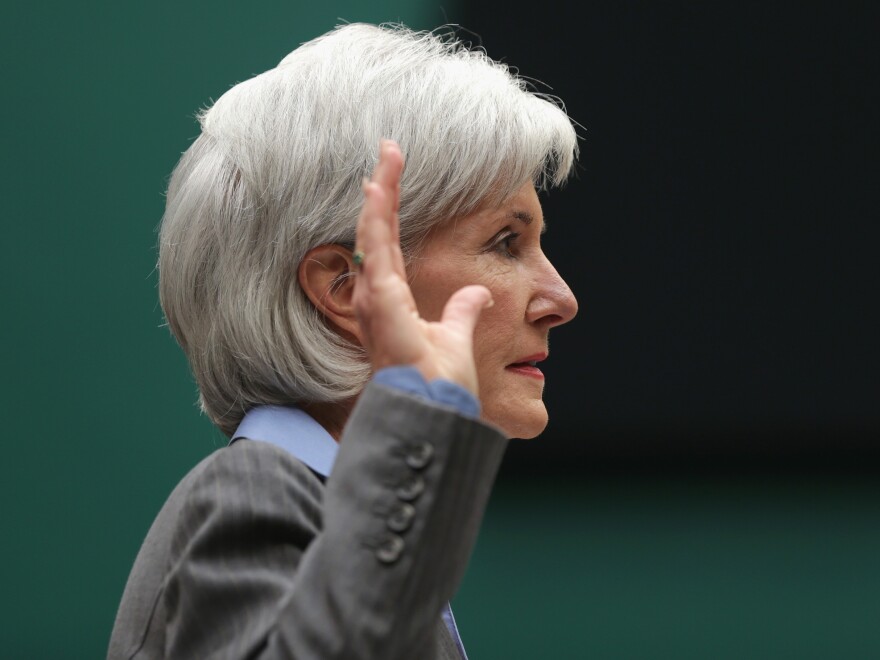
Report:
229,367,480,660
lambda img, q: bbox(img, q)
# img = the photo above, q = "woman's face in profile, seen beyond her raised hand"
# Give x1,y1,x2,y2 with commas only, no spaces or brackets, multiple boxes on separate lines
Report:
409,183,577,438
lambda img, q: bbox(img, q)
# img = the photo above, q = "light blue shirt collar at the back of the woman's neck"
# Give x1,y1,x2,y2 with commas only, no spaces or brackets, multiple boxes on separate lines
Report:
229,406,339,478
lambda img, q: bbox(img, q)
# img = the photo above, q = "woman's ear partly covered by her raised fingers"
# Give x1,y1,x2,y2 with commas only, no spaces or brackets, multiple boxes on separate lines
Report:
297,244,363,346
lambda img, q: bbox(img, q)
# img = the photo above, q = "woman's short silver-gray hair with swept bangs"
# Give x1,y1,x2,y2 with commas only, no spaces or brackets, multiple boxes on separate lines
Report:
159,24,577,435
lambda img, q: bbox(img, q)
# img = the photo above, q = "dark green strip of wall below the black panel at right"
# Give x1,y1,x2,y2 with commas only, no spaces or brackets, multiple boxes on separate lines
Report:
455,474,880,660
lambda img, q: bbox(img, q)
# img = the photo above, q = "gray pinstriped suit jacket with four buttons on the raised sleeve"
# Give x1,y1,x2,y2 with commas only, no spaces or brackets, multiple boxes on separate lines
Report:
108,383,506,659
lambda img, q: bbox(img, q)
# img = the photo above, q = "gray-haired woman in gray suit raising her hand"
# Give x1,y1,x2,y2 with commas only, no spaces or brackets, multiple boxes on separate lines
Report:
109,25,577,658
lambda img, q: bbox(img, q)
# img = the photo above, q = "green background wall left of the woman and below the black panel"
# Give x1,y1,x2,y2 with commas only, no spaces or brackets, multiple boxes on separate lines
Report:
0,1,880,659
